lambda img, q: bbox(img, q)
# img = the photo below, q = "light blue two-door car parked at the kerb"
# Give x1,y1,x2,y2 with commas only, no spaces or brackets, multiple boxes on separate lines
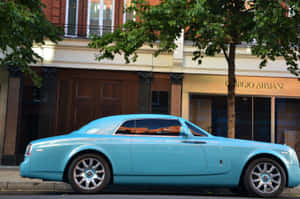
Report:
20,114,300,197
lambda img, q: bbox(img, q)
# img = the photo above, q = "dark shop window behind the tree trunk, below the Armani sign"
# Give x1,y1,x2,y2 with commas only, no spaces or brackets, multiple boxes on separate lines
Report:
189,94,271,142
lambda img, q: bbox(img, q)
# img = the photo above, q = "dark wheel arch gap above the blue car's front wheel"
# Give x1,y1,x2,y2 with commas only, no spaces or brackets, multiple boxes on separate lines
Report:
239,152,288,186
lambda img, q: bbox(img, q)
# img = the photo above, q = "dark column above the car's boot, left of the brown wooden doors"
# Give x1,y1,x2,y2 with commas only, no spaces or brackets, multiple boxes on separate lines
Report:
38,67,56,138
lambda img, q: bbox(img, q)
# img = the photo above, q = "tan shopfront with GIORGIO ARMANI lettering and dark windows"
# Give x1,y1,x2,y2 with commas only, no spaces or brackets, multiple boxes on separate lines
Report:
182,74,300,159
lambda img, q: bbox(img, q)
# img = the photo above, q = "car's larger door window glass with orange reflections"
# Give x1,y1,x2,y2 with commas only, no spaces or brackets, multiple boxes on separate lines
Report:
136,119,181,136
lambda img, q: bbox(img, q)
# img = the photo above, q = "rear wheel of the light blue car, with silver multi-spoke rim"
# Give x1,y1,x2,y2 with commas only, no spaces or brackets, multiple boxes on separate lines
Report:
68,153,111,194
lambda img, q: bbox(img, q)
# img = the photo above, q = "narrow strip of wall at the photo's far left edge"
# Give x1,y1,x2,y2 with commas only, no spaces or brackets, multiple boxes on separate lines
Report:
0,69,8,162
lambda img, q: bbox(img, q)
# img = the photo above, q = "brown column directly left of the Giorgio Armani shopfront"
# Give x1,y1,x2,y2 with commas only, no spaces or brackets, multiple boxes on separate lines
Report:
170,73,183,116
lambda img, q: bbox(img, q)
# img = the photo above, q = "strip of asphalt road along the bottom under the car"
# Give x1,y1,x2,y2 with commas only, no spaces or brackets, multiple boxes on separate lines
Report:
0,192,296,199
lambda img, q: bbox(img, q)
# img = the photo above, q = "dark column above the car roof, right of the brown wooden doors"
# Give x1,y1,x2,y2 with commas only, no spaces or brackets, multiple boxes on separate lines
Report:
138,72,152,113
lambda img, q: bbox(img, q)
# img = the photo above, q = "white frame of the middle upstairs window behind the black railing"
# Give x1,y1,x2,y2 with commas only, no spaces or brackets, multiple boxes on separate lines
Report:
87,0,115,37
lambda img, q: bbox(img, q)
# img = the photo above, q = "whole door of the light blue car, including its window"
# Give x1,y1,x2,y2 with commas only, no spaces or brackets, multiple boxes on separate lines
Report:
131,119,206,175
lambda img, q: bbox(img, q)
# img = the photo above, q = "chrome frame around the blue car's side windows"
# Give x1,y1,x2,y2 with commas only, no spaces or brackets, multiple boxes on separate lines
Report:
112,118,183,138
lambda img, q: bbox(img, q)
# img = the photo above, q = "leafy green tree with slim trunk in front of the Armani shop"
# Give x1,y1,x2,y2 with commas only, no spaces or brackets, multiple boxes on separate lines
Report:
89,0,300,138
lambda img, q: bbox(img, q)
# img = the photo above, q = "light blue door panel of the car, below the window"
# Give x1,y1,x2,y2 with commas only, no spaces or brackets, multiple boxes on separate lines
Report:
131,137,206,175
